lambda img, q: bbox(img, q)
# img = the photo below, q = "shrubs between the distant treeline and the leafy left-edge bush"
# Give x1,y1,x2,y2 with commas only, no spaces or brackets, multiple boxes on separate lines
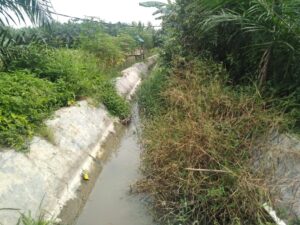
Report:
3,45,129,117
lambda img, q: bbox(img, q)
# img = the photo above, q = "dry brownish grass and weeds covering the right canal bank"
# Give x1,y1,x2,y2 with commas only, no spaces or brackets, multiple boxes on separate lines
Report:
137,60,295,225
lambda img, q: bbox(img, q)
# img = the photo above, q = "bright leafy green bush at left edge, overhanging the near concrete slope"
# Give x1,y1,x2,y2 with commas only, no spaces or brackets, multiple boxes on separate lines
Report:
0,72,73,150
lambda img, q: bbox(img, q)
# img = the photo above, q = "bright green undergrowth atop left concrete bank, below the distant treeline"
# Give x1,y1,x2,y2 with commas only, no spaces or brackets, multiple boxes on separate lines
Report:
0,45,130,150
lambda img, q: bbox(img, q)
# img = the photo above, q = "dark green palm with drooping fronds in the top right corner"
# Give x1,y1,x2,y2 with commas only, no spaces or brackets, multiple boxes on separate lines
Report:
198,0,300,90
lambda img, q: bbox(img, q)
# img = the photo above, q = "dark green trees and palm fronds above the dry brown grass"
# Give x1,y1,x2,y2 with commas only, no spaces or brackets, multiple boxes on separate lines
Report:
152,0,300,129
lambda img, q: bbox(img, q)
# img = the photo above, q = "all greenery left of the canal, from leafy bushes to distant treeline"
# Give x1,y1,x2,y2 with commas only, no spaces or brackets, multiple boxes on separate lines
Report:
0,18,157,150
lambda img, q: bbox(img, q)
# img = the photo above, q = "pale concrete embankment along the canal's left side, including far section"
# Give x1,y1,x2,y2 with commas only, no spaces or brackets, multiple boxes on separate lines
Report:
0,57,156,225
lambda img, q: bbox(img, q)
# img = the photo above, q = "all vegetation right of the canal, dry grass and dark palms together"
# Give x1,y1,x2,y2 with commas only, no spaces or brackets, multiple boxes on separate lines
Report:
137,0,300,225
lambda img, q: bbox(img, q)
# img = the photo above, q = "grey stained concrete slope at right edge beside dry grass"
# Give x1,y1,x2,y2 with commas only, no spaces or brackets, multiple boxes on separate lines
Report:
254,134,300,224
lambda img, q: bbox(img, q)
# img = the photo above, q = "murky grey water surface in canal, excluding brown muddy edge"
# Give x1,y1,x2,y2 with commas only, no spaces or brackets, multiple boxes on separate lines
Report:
75,106,154,225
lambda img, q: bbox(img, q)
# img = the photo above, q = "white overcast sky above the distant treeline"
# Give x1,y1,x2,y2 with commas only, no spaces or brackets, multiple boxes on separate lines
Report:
52,0,167,25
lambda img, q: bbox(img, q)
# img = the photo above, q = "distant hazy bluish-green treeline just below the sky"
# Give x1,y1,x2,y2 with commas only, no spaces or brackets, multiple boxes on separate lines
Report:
9,20,156,51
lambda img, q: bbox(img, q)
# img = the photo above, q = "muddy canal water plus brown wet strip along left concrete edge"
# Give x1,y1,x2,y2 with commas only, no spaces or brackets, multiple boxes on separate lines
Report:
60,105,155,225
